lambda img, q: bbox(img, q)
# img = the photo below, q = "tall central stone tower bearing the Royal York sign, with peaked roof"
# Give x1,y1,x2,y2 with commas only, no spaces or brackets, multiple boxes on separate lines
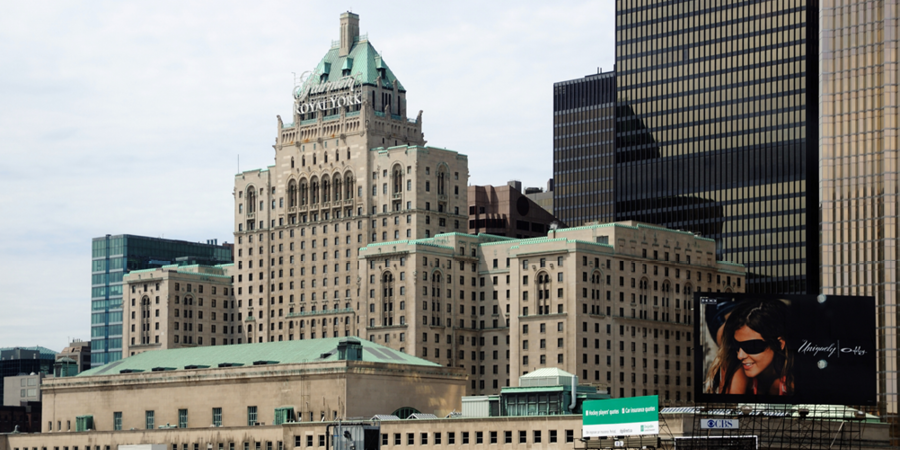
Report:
234,13,469,342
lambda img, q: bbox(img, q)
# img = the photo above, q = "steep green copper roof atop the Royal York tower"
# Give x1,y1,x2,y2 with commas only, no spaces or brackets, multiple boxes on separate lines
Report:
309,39,406,91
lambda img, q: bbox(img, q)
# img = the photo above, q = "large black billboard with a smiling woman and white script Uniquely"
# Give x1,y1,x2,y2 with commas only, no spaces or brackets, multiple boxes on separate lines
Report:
694,292,876,405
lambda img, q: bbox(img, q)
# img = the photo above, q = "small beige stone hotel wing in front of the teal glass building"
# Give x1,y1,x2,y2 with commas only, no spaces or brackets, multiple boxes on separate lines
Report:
122,264,237,356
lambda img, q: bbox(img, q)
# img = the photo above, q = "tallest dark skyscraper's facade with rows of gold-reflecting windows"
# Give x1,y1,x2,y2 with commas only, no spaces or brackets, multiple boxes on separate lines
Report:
615,0,819,294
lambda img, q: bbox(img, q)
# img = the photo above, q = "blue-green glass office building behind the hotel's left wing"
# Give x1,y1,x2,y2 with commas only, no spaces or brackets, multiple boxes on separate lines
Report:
91,234,232,367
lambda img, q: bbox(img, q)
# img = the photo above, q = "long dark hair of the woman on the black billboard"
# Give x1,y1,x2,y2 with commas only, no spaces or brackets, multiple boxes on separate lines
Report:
722,299,794,394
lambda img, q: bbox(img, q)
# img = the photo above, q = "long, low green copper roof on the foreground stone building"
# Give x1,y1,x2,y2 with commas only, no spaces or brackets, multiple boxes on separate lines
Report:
78,337,440,376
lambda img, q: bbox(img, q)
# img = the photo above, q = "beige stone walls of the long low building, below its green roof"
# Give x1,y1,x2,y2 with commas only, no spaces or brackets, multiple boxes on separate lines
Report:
42,354,466,433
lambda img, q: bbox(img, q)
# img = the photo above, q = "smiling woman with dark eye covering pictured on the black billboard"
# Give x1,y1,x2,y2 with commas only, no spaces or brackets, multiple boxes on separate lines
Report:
706,299,794,395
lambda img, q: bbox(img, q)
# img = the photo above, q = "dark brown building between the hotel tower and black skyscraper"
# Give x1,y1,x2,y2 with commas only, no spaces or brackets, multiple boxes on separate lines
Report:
468,181,559,238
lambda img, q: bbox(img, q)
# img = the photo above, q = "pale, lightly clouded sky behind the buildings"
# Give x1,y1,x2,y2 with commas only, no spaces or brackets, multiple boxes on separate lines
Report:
0,0,615,351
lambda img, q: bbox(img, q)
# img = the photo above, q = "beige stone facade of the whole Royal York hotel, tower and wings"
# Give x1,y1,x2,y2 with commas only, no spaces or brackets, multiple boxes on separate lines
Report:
119,15,745,403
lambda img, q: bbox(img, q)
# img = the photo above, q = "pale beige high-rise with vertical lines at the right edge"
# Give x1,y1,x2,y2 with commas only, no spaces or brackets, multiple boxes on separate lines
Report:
824,1,900,436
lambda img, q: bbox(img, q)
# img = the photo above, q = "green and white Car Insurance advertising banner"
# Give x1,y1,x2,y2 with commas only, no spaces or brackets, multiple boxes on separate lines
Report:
581,395,659,437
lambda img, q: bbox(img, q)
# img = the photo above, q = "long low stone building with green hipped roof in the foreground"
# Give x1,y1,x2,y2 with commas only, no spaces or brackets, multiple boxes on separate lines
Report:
42,337,466,433
